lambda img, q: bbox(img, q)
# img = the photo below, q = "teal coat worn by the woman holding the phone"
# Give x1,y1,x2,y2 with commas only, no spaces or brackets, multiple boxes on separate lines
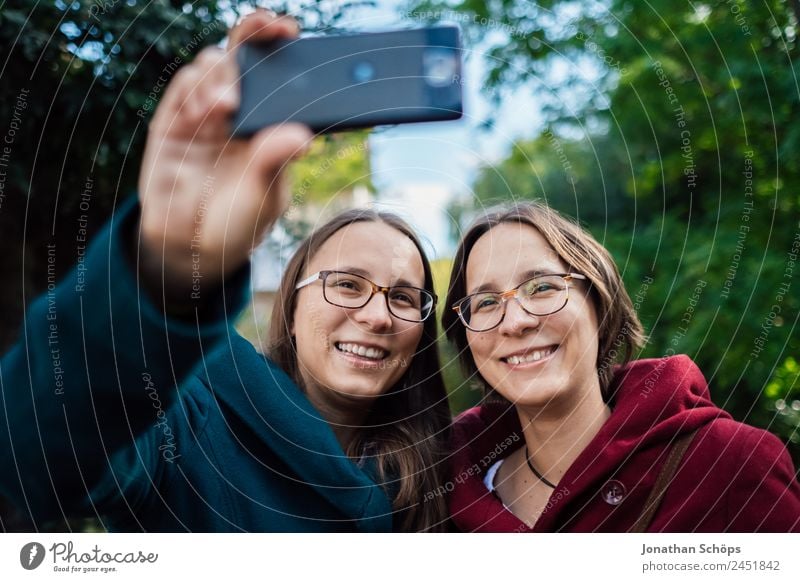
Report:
0,204,392,532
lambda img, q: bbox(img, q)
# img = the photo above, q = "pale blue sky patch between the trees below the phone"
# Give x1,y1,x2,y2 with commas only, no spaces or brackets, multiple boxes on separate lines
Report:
328,0,543,257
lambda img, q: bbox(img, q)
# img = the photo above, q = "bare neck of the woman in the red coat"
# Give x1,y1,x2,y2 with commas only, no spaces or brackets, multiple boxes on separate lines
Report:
517,384,611,483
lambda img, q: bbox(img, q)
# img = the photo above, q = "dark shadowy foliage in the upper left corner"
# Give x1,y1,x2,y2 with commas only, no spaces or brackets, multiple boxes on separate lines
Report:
0,0,230,346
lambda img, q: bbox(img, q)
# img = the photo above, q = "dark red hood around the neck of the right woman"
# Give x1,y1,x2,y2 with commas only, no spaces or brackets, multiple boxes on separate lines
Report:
450,355,730,531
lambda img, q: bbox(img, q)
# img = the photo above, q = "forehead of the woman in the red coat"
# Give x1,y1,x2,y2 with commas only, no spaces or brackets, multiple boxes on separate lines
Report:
466,223,567,293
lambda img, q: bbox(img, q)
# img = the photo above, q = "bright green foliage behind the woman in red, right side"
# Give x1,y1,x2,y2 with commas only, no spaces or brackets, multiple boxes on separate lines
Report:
428,0,800,460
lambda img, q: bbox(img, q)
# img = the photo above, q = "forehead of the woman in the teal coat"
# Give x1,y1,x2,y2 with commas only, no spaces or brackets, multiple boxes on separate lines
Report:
306,221,425,287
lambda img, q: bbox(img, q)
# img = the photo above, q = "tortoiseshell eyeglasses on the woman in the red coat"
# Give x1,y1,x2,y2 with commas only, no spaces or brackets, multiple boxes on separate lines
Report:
453,273,586,332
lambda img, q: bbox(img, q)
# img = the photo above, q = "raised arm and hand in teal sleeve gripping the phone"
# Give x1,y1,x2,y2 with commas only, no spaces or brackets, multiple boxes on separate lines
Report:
0,12,310,527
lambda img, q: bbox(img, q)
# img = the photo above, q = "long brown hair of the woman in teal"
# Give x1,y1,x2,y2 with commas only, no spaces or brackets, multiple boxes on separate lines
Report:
268,209,450,531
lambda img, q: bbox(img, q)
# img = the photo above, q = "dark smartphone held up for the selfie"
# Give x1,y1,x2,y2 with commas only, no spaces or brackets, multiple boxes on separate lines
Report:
233,26,462,137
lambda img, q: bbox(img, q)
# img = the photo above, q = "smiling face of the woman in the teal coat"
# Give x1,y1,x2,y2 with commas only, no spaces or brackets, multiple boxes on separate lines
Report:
291,221,425,406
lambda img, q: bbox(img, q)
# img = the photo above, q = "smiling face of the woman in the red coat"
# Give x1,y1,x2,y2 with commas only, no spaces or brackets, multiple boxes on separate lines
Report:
466,223,599,407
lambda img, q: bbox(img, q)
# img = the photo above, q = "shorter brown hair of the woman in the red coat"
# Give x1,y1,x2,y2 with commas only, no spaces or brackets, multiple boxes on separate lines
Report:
442,202,645,401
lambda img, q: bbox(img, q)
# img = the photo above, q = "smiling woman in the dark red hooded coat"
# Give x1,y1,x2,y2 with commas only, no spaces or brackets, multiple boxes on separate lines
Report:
443,203,800,532
